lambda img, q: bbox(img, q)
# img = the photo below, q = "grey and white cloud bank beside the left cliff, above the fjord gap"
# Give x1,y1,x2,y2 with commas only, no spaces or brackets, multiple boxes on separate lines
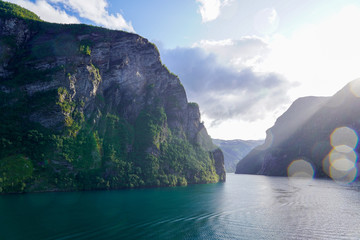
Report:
161,43,293,139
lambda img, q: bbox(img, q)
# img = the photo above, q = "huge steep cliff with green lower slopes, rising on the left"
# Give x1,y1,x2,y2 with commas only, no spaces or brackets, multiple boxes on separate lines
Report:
0,2,225,192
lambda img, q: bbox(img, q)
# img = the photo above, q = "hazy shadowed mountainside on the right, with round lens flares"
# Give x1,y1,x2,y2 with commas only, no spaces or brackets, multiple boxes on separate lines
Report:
236,80,360,181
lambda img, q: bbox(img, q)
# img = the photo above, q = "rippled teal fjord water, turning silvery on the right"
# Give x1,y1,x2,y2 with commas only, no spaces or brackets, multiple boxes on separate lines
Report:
0,174,360,240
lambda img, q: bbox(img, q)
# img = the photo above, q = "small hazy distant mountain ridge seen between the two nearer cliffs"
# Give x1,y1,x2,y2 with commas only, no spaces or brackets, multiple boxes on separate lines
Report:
213,139,264,173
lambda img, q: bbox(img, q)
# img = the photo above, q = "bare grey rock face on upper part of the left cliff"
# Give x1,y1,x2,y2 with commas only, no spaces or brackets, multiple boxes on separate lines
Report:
0,14,225,180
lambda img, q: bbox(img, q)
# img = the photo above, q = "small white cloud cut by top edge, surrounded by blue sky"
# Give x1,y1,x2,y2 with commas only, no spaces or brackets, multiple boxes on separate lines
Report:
196,0,232,23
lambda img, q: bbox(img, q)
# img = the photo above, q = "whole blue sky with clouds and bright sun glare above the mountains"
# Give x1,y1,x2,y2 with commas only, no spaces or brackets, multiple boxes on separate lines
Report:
8,0,360,140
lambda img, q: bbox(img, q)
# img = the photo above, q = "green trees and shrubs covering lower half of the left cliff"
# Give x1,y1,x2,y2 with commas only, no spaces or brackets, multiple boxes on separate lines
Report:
0,98,219,192
